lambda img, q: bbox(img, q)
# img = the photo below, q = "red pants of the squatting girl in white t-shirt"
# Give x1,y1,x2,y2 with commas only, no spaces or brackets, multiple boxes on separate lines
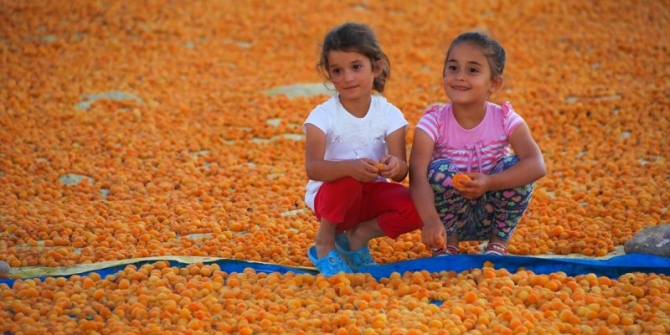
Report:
314,177,423,239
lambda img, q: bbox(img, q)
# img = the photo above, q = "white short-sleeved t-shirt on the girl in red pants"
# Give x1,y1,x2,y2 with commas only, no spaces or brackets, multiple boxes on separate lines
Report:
302,95,409,209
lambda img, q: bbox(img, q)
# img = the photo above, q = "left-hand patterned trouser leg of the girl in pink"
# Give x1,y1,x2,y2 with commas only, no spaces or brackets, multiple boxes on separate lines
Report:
428,159,473,251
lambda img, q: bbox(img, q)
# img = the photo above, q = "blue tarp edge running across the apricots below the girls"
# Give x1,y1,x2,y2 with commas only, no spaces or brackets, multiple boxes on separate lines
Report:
0,254,670,286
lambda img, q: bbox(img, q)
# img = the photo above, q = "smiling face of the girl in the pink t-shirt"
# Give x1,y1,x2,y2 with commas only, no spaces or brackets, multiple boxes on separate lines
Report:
443,42,501,104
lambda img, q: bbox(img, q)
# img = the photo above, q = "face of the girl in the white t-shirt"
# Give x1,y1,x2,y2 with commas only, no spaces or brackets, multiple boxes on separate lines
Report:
328,51,381,100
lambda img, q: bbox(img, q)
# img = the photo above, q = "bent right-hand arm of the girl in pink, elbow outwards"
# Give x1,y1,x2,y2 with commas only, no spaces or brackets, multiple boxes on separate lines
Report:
486,123,546,191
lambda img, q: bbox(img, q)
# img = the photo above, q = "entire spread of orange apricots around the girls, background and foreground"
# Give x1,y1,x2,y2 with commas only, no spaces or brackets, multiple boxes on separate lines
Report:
0,0,670,335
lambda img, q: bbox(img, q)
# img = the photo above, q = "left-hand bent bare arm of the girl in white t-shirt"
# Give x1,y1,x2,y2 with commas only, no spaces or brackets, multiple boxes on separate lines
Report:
305,124,378,181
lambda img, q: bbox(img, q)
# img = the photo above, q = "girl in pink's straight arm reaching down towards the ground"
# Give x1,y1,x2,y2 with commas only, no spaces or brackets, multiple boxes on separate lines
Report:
409,128,444,248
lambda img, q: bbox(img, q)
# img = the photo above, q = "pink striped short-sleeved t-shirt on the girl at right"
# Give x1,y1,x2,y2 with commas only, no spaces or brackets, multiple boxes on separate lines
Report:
416,102,525,174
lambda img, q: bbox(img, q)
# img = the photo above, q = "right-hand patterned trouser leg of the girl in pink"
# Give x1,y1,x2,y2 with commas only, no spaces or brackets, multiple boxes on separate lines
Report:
486,156,534,248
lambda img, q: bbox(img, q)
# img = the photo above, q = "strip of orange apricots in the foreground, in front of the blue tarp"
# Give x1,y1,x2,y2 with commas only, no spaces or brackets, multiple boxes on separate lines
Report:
0,261,670,335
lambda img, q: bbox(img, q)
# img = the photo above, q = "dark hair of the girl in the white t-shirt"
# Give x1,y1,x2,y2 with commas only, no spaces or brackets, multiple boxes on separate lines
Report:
316,22,391,93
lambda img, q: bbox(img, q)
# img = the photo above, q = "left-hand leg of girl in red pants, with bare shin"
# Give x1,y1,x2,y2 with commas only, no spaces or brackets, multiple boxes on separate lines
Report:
314,177,364,258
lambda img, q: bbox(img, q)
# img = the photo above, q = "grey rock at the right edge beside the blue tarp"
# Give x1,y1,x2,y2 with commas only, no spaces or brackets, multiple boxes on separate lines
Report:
623,224,670,257
